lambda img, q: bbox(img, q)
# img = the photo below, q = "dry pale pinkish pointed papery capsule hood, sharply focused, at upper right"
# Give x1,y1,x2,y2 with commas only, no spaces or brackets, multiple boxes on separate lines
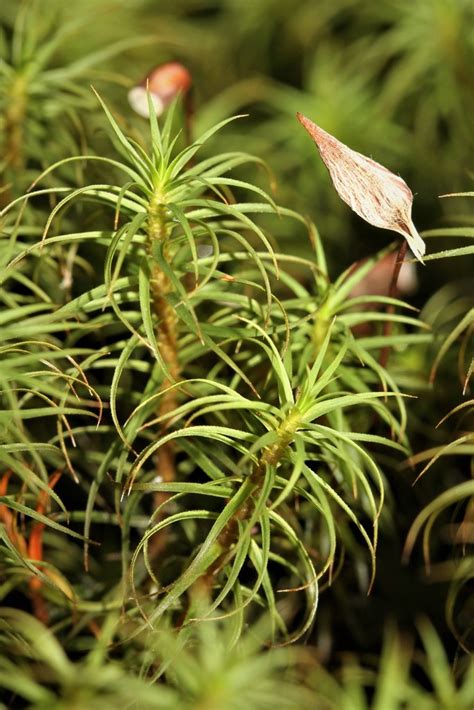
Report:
296,113,425,262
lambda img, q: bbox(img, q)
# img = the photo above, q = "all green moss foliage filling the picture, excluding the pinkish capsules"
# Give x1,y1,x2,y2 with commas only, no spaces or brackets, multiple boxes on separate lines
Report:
0,0,474,710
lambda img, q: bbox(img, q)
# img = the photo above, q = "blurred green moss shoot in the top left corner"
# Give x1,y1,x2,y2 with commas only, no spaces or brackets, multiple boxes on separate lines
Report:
0,0,156,196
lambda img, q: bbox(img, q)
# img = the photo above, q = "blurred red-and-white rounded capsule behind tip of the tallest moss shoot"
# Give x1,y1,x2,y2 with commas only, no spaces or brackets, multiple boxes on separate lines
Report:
128,62,192,118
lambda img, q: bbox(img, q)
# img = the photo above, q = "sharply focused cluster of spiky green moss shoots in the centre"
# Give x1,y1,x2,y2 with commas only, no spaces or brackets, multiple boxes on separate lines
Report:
3,96,408,634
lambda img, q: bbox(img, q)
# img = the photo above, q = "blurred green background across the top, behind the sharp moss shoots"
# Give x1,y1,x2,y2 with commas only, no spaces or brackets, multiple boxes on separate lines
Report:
0,0,474,284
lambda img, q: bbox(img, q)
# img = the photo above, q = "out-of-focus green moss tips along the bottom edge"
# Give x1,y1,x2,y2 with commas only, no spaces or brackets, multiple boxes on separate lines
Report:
0,609,474,710
